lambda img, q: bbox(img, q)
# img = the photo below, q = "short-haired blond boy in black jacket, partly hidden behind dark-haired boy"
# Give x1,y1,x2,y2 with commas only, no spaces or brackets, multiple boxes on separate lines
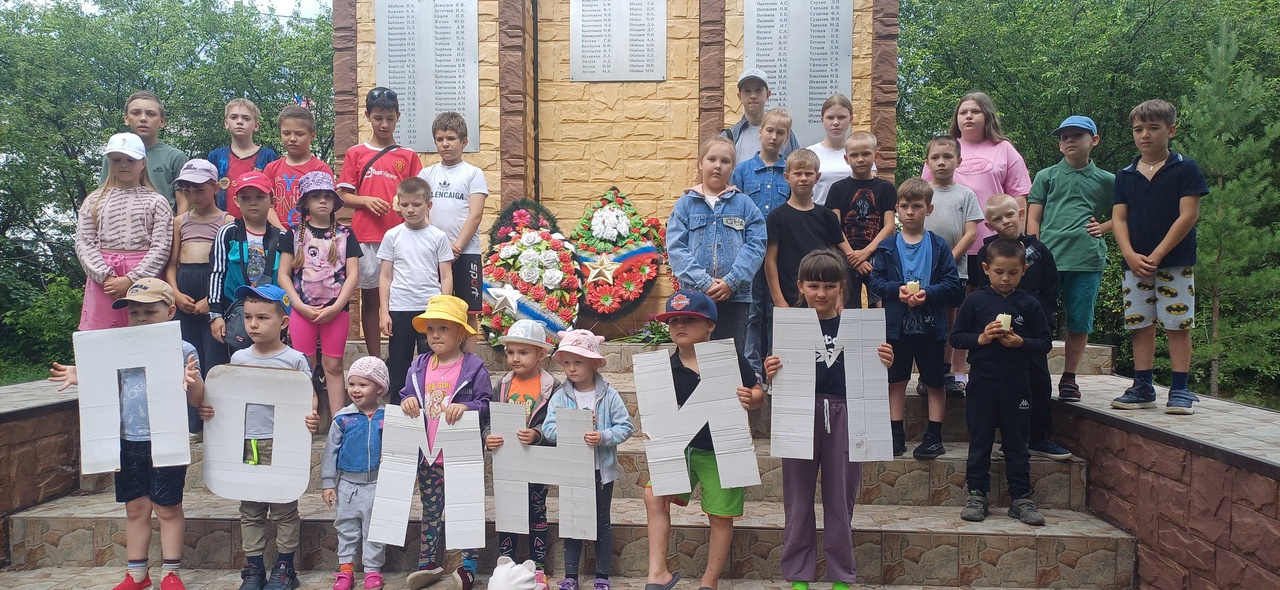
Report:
969,195,1071,461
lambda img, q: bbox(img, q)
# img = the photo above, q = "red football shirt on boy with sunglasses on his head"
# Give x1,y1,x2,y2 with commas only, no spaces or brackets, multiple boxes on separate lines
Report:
338,143,422,243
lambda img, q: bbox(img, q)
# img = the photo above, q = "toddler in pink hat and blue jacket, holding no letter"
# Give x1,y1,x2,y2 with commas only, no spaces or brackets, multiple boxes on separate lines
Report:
320,357,390,590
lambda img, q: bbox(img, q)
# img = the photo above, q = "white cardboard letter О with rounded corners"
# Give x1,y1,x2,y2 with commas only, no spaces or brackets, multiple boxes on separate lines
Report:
205,365,312,503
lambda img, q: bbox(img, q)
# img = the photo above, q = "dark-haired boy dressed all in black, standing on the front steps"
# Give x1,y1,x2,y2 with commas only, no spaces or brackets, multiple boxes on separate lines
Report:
951,238,1052,526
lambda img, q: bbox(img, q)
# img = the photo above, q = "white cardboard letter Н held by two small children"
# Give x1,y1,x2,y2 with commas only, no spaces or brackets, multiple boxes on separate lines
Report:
489,403,595,541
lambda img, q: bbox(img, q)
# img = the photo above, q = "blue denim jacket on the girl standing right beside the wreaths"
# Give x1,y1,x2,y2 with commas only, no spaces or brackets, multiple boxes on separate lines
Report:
667,186,764,303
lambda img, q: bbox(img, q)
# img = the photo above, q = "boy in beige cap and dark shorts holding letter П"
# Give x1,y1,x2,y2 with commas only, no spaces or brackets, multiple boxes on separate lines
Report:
49,278,205,590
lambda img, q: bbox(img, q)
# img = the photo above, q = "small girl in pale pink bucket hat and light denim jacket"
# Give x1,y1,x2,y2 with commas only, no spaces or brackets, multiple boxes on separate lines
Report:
543,330,632,590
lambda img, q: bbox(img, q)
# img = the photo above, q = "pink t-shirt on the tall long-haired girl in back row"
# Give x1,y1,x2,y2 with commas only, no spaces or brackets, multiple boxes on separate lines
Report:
920,140,1032,255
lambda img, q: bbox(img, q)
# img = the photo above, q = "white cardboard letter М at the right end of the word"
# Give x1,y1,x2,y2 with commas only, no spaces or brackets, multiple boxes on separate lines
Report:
769,307,893,462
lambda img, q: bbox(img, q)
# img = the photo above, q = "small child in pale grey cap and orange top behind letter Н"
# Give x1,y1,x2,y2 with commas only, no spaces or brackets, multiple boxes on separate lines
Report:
485,319,561,590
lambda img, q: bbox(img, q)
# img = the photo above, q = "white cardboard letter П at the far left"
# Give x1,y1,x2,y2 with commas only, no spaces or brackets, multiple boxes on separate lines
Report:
72,321,191,474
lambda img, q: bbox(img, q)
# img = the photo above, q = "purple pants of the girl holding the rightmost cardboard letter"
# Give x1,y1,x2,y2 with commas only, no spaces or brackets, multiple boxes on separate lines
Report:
782,393,863,584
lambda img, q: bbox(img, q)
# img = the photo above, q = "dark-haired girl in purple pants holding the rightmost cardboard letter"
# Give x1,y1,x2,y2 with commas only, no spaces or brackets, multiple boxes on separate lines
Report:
764,250,893,590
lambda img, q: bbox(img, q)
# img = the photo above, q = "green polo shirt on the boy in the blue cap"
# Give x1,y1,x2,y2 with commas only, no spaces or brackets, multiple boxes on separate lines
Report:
1027,159,1116,273
